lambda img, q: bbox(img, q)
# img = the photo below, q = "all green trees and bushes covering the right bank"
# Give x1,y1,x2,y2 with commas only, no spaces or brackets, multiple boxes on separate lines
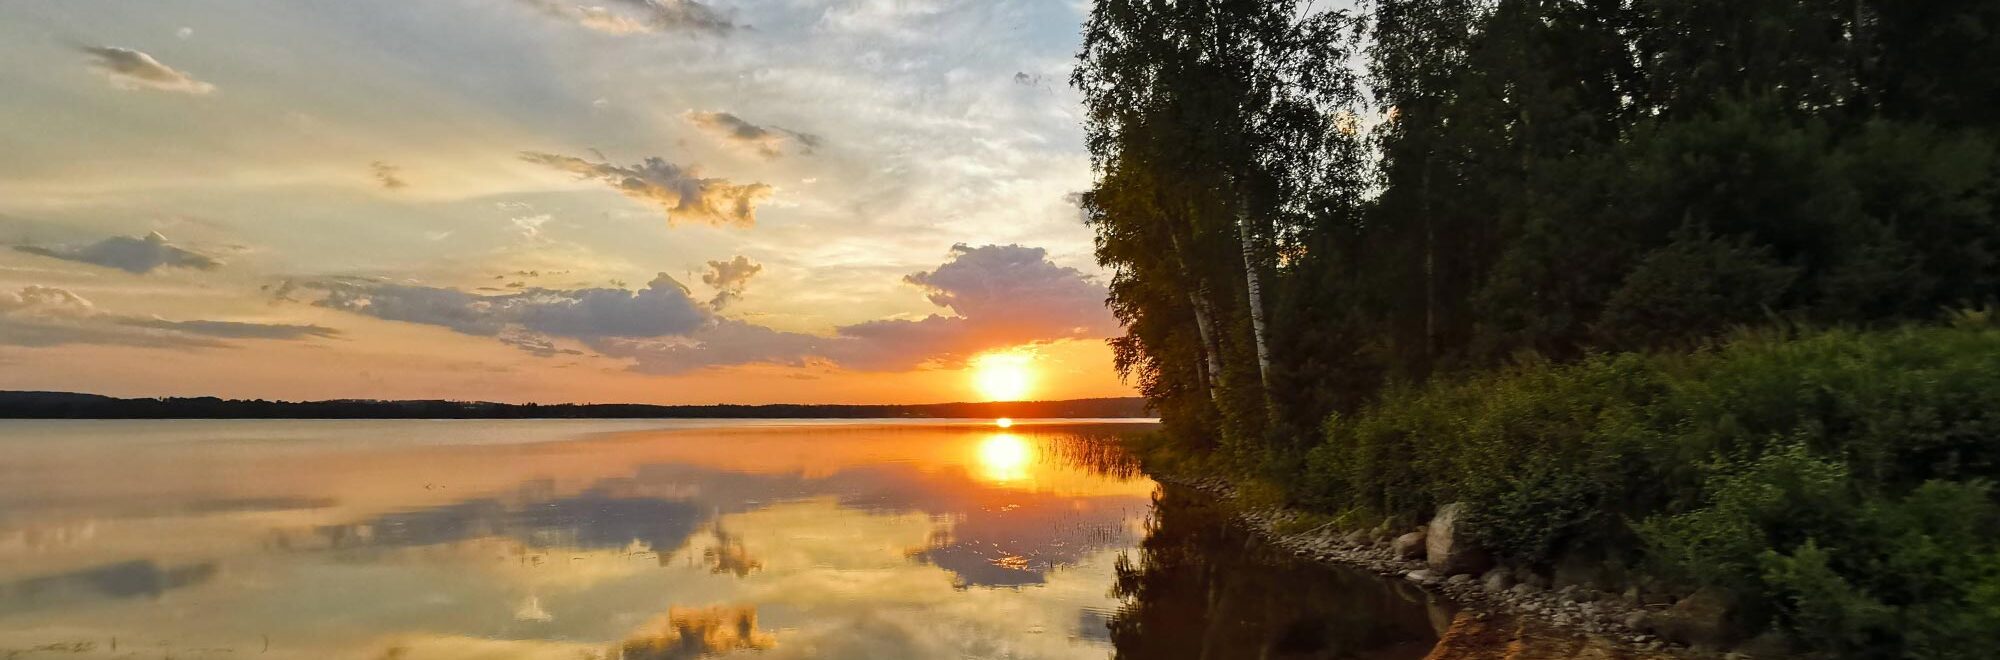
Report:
1074,0,2000,658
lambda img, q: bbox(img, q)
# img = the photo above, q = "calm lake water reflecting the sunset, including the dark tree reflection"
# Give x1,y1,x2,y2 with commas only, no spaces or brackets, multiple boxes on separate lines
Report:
0,420,1444,660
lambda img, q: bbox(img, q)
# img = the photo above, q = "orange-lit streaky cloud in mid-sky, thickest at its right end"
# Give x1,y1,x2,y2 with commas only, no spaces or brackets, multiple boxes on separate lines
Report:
520,152,772,228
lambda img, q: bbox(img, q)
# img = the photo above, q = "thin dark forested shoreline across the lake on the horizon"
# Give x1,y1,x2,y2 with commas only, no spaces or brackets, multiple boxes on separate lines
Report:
0,392,1152,420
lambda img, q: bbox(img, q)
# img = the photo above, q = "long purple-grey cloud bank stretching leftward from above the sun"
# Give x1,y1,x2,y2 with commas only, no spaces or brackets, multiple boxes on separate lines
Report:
292,244,1116,374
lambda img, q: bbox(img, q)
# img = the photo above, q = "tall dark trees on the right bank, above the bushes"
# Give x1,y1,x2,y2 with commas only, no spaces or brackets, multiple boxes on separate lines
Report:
1074,0,2000,462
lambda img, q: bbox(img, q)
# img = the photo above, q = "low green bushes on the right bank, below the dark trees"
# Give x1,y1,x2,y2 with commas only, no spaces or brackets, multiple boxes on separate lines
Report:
1298,314,2000,658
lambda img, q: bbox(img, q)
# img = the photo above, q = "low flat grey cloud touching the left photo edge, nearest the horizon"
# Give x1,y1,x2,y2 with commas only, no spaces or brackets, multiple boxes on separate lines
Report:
0,284,340,348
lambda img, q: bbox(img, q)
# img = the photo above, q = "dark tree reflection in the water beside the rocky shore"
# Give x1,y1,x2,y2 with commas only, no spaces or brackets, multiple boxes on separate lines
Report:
1106,486,1450,660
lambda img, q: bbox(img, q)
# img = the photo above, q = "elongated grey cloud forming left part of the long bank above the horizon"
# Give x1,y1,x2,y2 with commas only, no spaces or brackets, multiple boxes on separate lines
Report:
292,272,708,340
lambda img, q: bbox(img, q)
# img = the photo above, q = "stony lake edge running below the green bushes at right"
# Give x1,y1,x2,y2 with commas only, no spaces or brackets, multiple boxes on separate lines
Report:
1148,474,1720,660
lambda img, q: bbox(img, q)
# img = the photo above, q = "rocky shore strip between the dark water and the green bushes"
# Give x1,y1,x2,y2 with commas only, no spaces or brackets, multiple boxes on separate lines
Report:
1156,476,1764,660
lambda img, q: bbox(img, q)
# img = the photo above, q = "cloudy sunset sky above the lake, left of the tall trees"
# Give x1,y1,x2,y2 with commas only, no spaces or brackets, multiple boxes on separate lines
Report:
0,0,1132,404
